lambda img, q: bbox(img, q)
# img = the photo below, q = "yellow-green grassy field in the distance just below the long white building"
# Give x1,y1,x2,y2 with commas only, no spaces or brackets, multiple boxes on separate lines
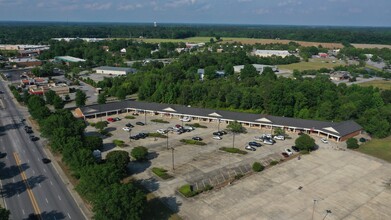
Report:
278,58,346,71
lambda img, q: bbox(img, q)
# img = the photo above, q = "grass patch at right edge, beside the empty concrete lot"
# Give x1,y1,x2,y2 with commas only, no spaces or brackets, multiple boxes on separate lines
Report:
358,136,391,162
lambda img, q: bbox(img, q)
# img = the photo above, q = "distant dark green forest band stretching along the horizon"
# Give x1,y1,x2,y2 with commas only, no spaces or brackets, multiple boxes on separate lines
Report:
0,22,391,44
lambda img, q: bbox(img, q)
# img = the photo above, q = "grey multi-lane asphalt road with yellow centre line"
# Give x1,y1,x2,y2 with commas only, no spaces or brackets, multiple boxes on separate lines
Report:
0,82,85,220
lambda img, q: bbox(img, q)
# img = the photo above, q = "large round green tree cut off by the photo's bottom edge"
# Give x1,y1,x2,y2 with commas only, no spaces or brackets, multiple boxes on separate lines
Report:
93,183,147,220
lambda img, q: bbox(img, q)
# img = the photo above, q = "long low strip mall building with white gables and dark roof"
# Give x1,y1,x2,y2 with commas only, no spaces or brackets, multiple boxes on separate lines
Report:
75,100,362,142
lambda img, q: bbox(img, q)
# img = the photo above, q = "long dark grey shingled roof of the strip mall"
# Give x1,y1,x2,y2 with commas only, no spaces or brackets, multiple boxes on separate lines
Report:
80,100,362,137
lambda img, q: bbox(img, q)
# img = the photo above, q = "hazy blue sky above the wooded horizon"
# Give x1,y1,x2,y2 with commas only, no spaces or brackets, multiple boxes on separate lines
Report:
0,0,391,27
